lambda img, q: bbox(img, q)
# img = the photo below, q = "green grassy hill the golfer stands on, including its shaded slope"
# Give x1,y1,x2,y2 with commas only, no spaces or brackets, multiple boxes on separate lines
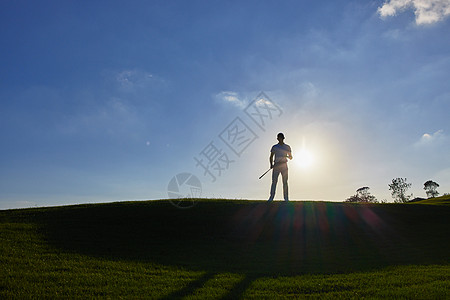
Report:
0,198,450,299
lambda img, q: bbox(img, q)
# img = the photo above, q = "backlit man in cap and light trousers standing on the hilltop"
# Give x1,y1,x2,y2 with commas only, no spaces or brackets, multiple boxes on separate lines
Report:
269,132,292,202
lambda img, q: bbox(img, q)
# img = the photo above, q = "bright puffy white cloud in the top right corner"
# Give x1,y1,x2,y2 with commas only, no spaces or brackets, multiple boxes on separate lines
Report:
378,0,450,25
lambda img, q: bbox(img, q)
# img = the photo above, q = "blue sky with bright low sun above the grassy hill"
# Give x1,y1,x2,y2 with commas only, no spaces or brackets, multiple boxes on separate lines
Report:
0,0,450,209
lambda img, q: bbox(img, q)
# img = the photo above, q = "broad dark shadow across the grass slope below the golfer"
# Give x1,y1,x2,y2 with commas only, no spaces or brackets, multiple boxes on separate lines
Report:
36,200,450,295
